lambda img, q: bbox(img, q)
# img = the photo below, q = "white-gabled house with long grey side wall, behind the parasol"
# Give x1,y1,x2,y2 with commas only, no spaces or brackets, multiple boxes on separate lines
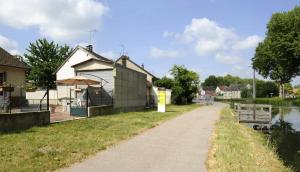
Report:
56,45,147,111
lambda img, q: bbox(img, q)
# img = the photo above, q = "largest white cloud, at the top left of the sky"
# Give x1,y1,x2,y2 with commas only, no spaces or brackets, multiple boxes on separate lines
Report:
0,0,108,40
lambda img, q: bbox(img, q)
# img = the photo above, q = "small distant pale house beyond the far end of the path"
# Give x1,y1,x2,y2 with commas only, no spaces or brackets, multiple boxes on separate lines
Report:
215,85,241,99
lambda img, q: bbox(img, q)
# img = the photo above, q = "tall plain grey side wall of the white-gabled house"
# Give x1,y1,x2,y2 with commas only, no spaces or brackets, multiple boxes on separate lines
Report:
114,66,147,112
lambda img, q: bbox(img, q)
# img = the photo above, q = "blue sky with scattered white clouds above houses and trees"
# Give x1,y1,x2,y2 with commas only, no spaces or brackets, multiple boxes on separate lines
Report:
0,0,300,84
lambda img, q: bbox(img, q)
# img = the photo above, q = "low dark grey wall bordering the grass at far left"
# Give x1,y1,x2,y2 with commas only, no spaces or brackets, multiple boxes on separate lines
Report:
0,111,50,132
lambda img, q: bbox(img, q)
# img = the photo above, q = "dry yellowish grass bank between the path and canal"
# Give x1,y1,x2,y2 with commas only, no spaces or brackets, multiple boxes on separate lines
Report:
206,108,292,172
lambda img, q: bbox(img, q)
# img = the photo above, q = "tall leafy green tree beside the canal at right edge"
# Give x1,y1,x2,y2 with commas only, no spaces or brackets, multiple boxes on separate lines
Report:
252,7,300,96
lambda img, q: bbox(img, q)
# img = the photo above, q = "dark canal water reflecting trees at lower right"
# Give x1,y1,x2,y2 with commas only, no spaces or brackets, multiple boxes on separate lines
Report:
270,107,300,172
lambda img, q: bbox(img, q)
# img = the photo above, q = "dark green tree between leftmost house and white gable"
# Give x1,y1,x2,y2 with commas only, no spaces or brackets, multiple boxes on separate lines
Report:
24,39,72,88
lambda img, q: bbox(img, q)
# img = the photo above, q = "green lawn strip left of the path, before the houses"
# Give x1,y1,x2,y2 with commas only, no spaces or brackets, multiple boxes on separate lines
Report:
0,104,199,172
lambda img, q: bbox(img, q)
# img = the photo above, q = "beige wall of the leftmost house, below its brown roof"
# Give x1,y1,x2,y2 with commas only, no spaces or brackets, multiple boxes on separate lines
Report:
0,66,25,97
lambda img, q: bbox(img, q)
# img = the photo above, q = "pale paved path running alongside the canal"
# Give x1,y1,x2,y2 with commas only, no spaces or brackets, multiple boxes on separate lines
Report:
62,103,226,172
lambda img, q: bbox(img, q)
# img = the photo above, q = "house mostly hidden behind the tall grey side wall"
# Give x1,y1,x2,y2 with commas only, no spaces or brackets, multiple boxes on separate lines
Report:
116,55,158,105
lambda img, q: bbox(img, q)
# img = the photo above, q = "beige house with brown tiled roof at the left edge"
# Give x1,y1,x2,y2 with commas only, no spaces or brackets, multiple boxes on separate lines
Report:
0,47,27,107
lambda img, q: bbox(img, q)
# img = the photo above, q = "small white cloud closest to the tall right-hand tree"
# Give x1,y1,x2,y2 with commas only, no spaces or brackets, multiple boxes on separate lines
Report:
232,35,262,50
